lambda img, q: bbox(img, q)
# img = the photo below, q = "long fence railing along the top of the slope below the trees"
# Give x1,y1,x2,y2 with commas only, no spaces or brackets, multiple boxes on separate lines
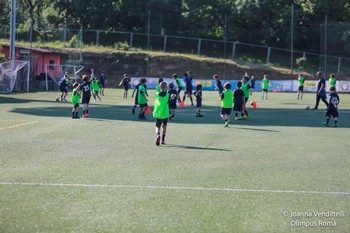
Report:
0,26,350,75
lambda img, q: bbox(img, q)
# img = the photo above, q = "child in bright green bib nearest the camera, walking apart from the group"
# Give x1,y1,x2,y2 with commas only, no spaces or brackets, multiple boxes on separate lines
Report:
153,82,170,146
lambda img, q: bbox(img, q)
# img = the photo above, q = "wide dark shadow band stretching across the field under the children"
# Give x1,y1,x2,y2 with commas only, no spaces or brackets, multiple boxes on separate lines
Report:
9,98,350,129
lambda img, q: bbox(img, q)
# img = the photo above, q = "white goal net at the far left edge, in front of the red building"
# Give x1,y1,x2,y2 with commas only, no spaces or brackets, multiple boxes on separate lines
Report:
0,60,29,93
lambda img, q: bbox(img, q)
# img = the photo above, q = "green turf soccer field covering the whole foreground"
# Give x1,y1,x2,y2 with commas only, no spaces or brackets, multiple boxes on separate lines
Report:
0,89,350,233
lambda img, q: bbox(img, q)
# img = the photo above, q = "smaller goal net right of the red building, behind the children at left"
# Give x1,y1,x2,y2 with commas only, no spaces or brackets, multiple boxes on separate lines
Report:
45,64,84,91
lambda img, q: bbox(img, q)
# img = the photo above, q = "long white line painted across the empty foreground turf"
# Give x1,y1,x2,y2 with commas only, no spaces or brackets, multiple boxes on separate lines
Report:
0,182,350,195
